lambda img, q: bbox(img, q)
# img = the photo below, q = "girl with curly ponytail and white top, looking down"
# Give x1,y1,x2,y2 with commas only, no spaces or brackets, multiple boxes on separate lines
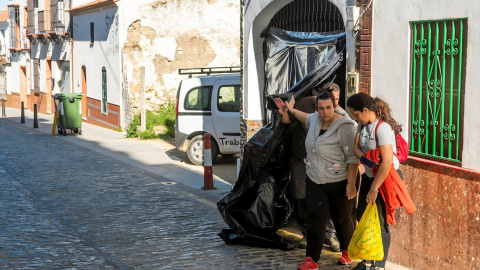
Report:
347,93,412,270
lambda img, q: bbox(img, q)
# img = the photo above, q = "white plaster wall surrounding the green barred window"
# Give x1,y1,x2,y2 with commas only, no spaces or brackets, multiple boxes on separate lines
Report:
371,0,480,170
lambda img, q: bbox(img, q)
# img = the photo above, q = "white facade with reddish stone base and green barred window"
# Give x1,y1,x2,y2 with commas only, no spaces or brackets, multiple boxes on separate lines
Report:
371,0,480,269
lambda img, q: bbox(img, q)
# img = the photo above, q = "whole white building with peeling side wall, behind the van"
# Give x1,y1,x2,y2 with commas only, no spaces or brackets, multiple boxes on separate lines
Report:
69,0,240,130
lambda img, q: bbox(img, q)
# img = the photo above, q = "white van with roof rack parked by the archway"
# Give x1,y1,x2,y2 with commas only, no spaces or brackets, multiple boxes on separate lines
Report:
175,67,240,165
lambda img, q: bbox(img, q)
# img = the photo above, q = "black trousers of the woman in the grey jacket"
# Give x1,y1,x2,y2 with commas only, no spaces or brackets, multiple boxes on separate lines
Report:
306,177,354,262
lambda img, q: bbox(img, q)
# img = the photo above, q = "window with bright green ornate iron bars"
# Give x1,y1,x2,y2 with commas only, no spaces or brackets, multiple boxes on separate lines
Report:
410,18,467,163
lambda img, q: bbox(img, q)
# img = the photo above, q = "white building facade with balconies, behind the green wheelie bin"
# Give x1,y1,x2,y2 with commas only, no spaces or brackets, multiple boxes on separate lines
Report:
26,0,71,114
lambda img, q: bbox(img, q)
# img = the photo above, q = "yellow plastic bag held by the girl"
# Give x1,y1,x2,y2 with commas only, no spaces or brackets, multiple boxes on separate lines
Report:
348,203,383,261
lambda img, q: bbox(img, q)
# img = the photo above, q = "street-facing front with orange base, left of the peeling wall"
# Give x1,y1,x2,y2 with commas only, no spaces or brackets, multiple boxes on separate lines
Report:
69,1,123,130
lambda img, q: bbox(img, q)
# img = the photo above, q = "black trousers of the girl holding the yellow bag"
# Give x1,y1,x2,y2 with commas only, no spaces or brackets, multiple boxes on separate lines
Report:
357,170,403,268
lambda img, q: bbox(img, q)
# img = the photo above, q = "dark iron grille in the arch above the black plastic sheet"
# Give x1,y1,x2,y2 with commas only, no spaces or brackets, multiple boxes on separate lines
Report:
268,0,345,32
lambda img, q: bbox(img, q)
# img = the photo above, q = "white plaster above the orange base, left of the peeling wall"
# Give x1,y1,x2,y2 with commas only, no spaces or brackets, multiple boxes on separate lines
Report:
73,8,121,106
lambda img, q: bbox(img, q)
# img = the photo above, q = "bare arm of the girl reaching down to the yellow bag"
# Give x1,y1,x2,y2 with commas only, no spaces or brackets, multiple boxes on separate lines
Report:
367,144,393,203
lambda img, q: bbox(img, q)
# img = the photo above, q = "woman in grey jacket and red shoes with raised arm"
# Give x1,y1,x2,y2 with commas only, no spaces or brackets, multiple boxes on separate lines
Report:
275,91,359,270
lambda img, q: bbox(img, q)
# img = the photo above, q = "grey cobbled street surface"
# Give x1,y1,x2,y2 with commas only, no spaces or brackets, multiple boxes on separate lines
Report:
0,119,350,269
